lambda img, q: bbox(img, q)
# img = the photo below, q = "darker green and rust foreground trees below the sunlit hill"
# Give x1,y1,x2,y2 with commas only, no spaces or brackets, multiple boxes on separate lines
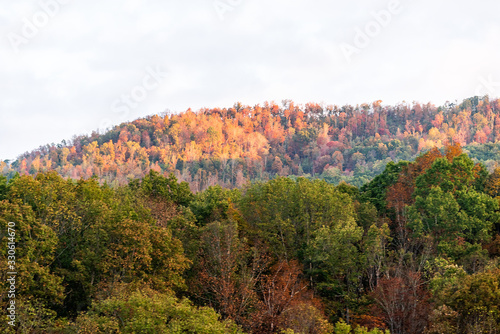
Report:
0,144,500,334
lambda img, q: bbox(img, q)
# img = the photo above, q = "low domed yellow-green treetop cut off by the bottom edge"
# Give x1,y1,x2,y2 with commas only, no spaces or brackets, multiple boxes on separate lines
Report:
70,288,243,334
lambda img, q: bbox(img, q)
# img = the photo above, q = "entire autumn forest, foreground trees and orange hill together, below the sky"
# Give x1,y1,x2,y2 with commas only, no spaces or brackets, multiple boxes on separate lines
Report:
0,97,500,334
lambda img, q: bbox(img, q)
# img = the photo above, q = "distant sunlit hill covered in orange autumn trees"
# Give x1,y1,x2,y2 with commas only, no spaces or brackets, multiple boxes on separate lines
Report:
0,96,500,191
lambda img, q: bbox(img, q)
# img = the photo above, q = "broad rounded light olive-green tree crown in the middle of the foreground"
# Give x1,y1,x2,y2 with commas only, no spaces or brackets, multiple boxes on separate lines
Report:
239,177,355,261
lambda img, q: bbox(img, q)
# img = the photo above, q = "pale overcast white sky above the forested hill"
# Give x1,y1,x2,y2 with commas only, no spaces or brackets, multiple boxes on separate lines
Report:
0,0,500,160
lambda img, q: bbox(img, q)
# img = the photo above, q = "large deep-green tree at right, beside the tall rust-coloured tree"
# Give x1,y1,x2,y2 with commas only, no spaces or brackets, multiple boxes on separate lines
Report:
407,154,500,267
